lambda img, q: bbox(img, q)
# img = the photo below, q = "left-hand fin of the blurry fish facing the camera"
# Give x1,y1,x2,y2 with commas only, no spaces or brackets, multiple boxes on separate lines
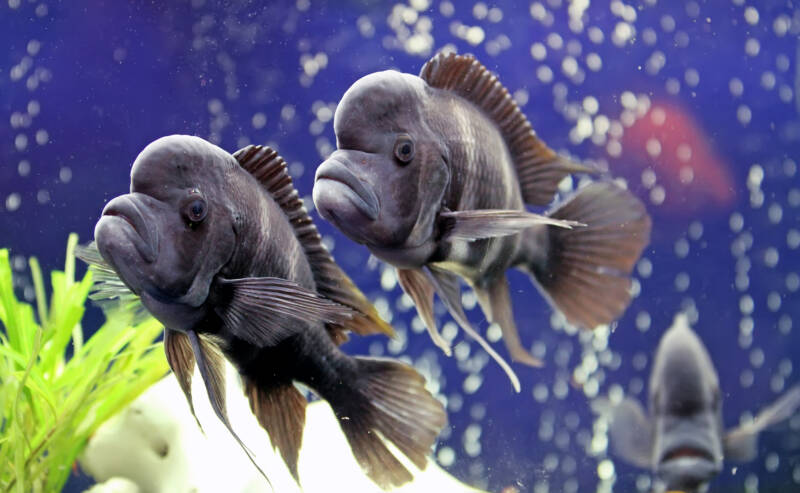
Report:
592,398,653,469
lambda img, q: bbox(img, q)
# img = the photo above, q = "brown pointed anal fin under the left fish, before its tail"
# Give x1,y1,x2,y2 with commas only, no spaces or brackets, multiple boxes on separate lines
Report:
245,379,308,482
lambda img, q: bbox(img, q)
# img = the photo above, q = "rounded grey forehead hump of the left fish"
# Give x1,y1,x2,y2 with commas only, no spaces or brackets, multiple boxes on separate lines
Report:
131,135,235,188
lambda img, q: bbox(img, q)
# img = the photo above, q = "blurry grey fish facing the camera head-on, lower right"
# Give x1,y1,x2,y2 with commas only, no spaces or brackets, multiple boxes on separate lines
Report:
593,315,800,493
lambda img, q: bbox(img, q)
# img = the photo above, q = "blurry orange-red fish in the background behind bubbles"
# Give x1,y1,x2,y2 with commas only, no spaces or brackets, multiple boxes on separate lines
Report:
611,100,736,213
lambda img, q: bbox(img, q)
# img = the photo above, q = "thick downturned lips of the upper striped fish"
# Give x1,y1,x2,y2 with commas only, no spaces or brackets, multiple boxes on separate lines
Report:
313,159,380,221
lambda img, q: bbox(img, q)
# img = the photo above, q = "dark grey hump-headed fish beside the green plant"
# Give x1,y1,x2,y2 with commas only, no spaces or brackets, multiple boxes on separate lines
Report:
81,136,446,488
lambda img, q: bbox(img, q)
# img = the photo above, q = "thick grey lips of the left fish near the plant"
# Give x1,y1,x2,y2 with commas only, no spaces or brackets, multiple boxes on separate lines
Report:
95,195,158,267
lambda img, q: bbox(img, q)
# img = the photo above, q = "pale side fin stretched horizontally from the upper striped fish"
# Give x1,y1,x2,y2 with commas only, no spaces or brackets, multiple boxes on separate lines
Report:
439,209,584,241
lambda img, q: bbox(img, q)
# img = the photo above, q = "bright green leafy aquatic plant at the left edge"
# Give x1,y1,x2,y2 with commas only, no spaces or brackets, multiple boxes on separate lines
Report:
0,235,168,493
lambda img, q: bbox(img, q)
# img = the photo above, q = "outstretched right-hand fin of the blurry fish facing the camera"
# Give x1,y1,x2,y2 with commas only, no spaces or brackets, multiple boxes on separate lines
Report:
723,385,800,462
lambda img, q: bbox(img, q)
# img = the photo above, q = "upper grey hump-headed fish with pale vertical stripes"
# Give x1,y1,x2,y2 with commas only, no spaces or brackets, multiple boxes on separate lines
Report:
313,54,650,390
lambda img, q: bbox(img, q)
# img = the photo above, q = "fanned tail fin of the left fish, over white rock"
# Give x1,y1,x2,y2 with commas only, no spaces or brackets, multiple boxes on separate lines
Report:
329,358,447,489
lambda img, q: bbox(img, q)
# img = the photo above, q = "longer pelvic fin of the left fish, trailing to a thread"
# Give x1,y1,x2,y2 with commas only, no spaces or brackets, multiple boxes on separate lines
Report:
186,330,272,488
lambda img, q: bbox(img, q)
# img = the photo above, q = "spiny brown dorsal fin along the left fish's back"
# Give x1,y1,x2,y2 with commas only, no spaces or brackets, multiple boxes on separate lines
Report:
233,145,394,344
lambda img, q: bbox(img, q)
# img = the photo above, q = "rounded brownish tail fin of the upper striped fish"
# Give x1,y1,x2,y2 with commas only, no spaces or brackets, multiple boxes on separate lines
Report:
529,182,651,328
